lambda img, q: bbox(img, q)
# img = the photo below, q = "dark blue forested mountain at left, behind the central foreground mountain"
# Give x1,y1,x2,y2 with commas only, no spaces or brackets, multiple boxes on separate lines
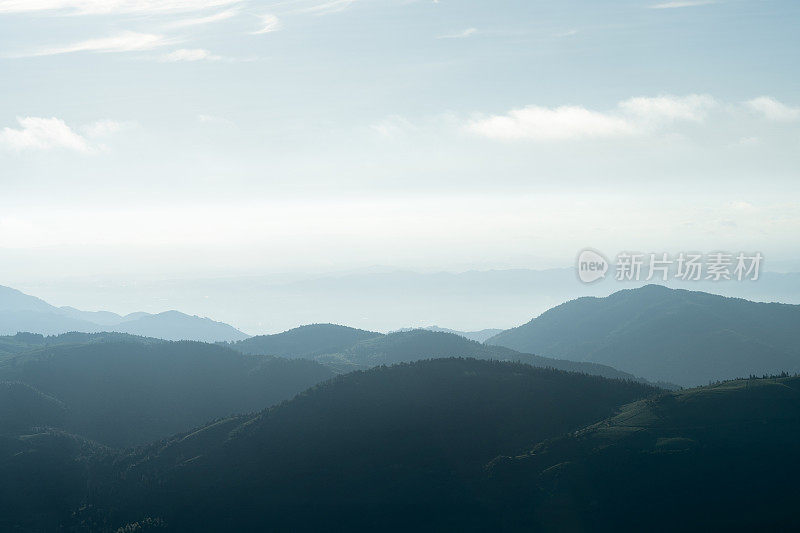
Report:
0,334,333,447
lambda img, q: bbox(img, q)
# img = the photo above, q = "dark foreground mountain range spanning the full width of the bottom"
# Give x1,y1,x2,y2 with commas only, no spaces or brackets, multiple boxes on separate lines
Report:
0,358,800,532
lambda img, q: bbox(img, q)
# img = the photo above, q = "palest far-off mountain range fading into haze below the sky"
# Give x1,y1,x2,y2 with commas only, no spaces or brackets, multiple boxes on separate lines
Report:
26,268,800,333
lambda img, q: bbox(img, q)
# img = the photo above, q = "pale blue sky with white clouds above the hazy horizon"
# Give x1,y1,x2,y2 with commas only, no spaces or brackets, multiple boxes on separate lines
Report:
0,0,800,288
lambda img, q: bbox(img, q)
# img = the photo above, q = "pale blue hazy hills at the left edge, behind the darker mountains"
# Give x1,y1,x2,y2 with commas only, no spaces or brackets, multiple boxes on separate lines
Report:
0,286,248,342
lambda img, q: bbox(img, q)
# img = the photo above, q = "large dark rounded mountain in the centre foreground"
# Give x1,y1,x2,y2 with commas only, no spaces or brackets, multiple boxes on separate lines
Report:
84,359,657,531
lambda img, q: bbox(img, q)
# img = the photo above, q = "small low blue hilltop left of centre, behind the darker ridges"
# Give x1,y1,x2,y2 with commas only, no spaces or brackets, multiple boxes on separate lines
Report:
231,324,382,359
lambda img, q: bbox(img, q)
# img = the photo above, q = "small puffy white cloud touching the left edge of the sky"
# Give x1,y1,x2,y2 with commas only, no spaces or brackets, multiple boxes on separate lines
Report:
0,117,93,153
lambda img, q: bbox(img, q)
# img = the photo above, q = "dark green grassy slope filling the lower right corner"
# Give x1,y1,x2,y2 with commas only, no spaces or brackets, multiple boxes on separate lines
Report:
487,377,800,531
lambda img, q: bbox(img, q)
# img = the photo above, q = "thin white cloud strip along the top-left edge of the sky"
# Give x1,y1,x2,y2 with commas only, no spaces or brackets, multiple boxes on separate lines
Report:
0,0,241,15
